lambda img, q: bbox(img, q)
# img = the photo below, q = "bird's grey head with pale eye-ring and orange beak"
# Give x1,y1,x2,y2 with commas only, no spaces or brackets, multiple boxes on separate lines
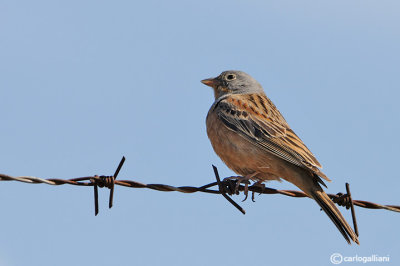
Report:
201,70,264,99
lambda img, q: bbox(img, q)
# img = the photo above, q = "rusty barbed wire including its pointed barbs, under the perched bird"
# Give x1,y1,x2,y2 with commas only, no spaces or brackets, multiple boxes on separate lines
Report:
0,157,400,220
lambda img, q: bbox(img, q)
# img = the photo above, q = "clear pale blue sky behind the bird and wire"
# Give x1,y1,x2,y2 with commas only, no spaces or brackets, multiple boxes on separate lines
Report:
0,0,400,266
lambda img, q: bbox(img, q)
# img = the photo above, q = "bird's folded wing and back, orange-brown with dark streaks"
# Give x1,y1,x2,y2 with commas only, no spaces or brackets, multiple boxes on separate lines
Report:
214,94,330,181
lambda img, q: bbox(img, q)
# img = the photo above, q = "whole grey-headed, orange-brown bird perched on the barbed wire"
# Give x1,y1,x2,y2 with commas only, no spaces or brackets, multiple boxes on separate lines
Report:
201,70,359,244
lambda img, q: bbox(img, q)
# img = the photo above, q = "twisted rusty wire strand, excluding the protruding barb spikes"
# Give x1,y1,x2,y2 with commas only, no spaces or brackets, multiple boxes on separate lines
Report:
0,174,400,212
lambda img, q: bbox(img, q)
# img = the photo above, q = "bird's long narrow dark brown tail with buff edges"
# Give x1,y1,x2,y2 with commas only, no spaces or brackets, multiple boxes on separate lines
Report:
310,190,360,244
